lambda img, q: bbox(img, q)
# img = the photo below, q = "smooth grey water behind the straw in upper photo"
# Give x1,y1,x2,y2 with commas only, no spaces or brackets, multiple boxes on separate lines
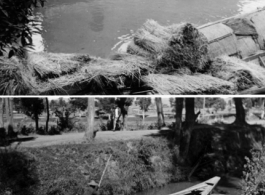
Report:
35,0,265,57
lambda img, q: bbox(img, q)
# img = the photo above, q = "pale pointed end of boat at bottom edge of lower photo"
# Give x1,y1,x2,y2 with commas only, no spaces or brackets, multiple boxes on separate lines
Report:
169,176,221,195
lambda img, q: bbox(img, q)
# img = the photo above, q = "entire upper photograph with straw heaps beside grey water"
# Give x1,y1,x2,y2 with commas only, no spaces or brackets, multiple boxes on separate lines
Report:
0,0,265,95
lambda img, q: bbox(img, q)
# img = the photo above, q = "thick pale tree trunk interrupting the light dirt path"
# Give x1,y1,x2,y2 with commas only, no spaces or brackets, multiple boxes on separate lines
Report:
85,97,95,141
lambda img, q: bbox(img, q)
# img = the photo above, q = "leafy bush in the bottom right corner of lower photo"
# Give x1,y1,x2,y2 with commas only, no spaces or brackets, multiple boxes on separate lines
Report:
242,146,265,195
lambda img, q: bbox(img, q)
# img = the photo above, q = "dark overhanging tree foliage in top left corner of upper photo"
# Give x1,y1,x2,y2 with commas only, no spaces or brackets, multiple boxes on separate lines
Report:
0,0,45,56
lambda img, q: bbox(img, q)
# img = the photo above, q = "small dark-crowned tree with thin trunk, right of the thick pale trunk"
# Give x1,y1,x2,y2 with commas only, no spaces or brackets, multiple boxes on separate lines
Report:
115,98,134,131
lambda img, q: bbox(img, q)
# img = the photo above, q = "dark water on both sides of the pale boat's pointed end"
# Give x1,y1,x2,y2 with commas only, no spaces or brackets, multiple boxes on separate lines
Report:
135,177,241,195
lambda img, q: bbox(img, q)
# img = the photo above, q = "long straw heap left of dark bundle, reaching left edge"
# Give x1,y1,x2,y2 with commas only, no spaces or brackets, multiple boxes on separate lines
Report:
0,53,152,95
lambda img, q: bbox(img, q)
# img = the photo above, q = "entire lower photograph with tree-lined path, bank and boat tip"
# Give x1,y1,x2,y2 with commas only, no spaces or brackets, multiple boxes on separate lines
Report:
0,97,265,195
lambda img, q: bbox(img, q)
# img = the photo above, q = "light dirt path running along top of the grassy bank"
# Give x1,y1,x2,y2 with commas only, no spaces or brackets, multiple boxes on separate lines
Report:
13,130,159,147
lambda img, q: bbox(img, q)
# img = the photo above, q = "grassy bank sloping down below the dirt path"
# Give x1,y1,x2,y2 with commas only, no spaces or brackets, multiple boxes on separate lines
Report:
0,138,185,195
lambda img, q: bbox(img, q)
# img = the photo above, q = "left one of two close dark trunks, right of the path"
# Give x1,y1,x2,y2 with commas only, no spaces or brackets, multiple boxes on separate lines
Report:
174,98,184,146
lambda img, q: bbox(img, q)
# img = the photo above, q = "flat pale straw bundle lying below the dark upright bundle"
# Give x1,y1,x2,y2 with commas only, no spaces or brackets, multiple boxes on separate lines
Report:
143,74,235,95
